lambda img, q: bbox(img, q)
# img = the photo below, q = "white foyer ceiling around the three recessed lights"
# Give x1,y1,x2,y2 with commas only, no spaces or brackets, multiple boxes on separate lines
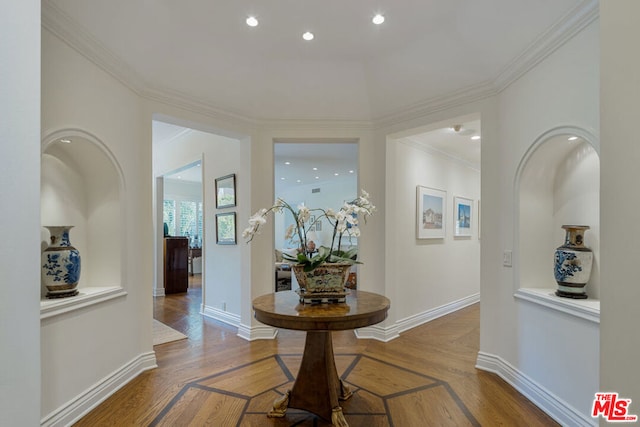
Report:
42,0,597,121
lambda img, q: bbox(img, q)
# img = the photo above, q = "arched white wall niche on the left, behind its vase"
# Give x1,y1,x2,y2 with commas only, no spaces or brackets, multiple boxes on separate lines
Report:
40,129,126,317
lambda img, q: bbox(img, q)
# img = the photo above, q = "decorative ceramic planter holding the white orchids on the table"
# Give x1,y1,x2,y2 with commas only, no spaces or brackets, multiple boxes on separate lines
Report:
292,263,351,295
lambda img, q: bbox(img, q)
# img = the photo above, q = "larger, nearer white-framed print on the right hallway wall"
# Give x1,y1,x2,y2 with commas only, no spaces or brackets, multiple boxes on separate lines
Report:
416,185,447,239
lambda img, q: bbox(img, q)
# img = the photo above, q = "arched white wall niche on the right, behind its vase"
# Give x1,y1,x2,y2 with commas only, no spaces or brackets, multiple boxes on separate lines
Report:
514,126,600,304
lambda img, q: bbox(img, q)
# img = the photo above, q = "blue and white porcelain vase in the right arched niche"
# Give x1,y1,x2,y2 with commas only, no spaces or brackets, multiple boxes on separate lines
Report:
553,225,593,299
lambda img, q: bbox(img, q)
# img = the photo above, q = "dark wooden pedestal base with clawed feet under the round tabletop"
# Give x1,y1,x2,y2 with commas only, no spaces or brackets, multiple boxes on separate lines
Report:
267,331,351,427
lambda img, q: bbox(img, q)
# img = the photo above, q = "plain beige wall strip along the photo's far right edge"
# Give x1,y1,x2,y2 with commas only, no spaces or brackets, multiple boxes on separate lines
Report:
600,0,640,416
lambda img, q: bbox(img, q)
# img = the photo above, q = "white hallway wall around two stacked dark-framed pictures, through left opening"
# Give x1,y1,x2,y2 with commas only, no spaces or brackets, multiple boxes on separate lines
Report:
153,130,246,318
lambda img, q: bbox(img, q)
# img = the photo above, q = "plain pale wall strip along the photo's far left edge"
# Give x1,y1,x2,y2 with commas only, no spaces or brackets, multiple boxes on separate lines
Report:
0,0,41,426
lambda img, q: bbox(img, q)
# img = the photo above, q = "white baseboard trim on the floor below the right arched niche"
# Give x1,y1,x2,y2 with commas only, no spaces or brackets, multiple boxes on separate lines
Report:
476,351,597,427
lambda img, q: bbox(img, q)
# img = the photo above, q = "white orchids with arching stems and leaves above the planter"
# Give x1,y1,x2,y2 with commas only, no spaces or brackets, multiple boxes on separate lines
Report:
242,190,376,271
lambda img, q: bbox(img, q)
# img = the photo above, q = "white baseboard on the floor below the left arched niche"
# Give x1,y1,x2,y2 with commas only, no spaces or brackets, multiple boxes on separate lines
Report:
40,352,158,427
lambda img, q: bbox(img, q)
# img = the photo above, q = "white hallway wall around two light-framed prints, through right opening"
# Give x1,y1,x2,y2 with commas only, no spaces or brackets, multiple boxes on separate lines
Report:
387,138,480,329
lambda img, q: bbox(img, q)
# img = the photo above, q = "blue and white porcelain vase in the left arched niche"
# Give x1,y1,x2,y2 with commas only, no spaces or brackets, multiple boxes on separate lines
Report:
41,225,80,298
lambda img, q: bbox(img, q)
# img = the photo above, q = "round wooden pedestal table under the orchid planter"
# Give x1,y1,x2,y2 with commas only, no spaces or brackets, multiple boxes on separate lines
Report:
253,290,390,427
